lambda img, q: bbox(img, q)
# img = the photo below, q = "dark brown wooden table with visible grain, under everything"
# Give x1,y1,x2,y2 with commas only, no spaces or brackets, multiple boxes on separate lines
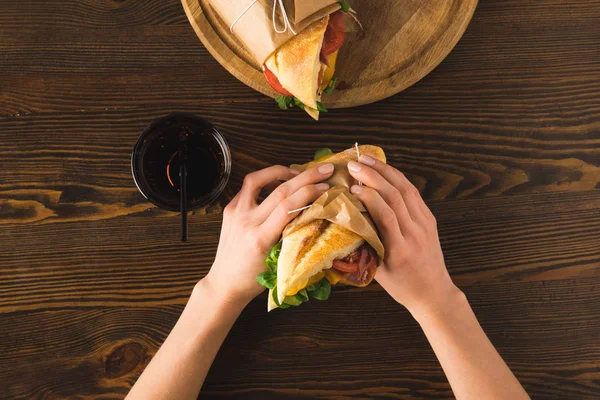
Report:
0,0,600,399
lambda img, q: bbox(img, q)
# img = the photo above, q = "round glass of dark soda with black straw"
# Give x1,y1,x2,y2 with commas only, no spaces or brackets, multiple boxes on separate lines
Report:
131,113,231,211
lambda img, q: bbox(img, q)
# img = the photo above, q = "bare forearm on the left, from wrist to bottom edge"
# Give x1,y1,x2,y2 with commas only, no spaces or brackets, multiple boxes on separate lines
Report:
127,280,246,400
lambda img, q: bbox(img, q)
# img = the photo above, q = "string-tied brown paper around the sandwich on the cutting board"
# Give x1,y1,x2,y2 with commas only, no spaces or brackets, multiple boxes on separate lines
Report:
210,0,340,65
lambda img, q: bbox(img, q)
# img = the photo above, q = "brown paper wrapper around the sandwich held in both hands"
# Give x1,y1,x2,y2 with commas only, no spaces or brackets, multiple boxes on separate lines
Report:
283,155,384,262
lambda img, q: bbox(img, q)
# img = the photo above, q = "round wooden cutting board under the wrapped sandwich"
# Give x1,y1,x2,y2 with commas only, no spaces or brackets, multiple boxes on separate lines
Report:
181,0,477,108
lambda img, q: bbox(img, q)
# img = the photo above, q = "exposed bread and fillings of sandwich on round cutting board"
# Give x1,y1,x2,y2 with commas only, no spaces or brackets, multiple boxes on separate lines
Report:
263,10,345,120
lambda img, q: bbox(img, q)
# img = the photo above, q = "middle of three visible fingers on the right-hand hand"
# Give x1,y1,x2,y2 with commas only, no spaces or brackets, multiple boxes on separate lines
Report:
348,161,415,234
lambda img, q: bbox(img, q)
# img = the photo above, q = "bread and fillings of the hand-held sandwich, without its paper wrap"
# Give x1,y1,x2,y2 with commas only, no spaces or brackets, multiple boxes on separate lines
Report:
257,145,386,311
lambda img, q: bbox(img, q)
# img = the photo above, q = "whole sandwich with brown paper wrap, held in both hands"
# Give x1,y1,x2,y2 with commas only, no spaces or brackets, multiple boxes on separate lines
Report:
256,145,385,311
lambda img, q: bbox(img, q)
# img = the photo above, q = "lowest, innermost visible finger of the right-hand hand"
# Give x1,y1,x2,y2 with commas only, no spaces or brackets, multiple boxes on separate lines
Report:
350,185,404,245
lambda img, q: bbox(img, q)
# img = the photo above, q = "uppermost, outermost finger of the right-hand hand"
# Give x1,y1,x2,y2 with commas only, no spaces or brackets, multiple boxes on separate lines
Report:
359,155,425,221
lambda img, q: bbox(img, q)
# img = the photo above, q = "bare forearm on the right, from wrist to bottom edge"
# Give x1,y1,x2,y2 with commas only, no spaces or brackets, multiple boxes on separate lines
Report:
413,289,529,400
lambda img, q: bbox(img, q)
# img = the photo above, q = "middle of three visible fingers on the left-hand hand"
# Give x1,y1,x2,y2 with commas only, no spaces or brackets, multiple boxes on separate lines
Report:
257,164,334,219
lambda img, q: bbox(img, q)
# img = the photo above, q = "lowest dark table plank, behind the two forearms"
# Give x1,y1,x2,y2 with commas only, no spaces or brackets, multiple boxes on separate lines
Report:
0,278,600,399
